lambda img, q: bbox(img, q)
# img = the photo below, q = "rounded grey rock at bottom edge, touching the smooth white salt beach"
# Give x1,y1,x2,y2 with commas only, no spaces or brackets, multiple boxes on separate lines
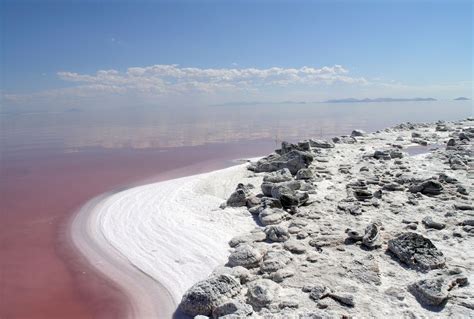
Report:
179,275,242,316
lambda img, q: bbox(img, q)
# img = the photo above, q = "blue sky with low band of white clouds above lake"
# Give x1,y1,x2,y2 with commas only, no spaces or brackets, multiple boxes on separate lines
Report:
0,0,473,106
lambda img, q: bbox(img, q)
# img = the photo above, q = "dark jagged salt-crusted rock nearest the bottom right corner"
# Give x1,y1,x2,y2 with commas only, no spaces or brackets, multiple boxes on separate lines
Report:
409,275,468,306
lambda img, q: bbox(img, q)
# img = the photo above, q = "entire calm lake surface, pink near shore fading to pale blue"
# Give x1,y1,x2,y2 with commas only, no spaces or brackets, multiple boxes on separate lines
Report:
0,101,473,319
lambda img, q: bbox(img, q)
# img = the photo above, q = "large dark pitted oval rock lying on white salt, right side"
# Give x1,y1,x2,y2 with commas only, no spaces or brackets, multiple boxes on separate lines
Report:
388,232,445,271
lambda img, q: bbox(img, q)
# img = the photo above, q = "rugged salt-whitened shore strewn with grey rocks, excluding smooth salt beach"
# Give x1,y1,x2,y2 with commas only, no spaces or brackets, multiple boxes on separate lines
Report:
179,119,474,318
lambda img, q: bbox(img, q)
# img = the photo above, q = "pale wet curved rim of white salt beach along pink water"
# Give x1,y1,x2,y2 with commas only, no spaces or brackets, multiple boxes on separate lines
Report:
65,159,264,318
